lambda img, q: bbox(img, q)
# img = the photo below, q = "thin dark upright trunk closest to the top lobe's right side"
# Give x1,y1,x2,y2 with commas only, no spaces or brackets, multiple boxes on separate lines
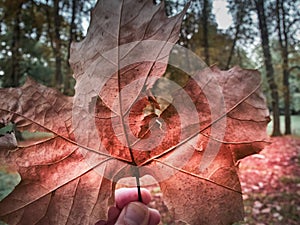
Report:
202,0,210,66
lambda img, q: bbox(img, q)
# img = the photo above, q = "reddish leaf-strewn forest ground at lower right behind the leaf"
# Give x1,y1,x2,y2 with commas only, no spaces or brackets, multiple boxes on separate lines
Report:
150,136,300,225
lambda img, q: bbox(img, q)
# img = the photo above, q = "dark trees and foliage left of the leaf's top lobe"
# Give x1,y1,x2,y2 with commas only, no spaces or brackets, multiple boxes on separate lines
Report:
0,0,94,93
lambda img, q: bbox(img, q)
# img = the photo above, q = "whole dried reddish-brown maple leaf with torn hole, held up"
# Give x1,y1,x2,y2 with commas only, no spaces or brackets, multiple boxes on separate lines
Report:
0,0,269,225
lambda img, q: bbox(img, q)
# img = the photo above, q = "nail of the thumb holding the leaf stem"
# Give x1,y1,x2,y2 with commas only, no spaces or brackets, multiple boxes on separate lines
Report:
124,202,149,225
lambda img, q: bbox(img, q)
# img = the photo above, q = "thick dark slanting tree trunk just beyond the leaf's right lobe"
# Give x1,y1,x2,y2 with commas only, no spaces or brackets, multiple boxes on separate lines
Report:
255,0,281,136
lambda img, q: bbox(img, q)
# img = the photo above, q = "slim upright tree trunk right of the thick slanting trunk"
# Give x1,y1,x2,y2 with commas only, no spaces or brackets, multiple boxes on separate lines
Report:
276,0,291,134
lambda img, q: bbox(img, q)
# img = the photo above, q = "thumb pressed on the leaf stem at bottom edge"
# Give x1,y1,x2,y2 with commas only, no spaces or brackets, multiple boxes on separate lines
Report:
115,202,149,225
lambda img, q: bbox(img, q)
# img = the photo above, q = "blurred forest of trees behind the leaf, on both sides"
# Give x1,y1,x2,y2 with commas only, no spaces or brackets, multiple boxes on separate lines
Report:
0,0,300,136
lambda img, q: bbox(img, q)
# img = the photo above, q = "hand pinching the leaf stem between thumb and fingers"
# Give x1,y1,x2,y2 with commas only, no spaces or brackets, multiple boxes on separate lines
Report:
95,188,160,225
